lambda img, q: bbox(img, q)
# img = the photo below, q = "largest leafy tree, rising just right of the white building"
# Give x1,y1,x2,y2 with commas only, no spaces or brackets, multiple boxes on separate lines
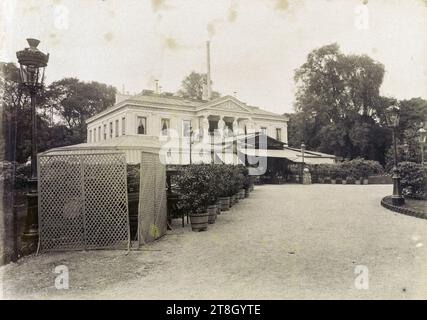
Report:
289,44,391,163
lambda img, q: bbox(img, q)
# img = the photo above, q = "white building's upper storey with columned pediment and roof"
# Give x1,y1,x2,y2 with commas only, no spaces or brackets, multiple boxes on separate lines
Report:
86,92,288,144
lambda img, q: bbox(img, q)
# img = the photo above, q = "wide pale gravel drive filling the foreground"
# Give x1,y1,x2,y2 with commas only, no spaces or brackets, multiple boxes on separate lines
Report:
0,185,427,299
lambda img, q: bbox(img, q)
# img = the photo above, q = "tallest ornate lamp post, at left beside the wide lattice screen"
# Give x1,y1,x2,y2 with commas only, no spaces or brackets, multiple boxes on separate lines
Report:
16,38,49,239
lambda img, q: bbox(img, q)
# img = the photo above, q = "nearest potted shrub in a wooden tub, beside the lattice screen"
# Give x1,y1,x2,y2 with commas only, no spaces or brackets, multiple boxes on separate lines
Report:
177,165,211,231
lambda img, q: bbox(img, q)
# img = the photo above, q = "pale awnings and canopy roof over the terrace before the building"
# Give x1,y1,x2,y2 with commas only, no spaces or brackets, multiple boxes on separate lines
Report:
47,133,335,165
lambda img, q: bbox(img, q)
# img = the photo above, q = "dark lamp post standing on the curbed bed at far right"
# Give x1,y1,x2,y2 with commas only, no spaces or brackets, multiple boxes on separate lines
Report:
386,106,405,206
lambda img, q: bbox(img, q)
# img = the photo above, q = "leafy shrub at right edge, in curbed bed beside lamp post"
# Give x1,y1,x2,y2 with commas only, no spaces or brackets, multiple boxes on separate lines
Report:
398,162,427,199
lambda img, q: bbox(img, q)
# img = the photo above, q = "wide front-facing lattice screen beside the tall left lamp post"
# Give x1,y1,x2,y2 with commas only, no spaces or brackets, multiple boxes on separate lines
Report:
38,152,130,251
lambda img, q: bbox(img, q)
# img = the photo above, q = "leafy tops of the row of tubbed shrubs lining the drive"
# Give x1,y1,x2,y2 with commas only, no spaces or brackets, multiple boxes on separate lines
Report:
177,164,251,214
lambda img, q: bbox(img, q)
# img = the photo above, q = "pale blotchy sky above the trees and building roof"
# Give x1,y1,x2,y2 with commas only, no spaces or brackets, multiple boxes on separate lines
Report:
0,0,427,114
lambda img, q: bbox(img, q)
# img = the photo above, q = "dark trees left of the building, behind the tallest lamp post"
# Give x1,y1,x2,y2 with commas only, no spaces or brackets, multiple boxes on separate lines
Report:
0,63,116,162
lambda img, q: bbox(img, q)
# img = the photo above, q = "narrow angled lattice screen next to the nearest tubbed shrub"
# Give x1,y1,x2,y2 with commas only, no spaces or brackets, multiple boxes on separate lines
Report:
138,152,167,245
